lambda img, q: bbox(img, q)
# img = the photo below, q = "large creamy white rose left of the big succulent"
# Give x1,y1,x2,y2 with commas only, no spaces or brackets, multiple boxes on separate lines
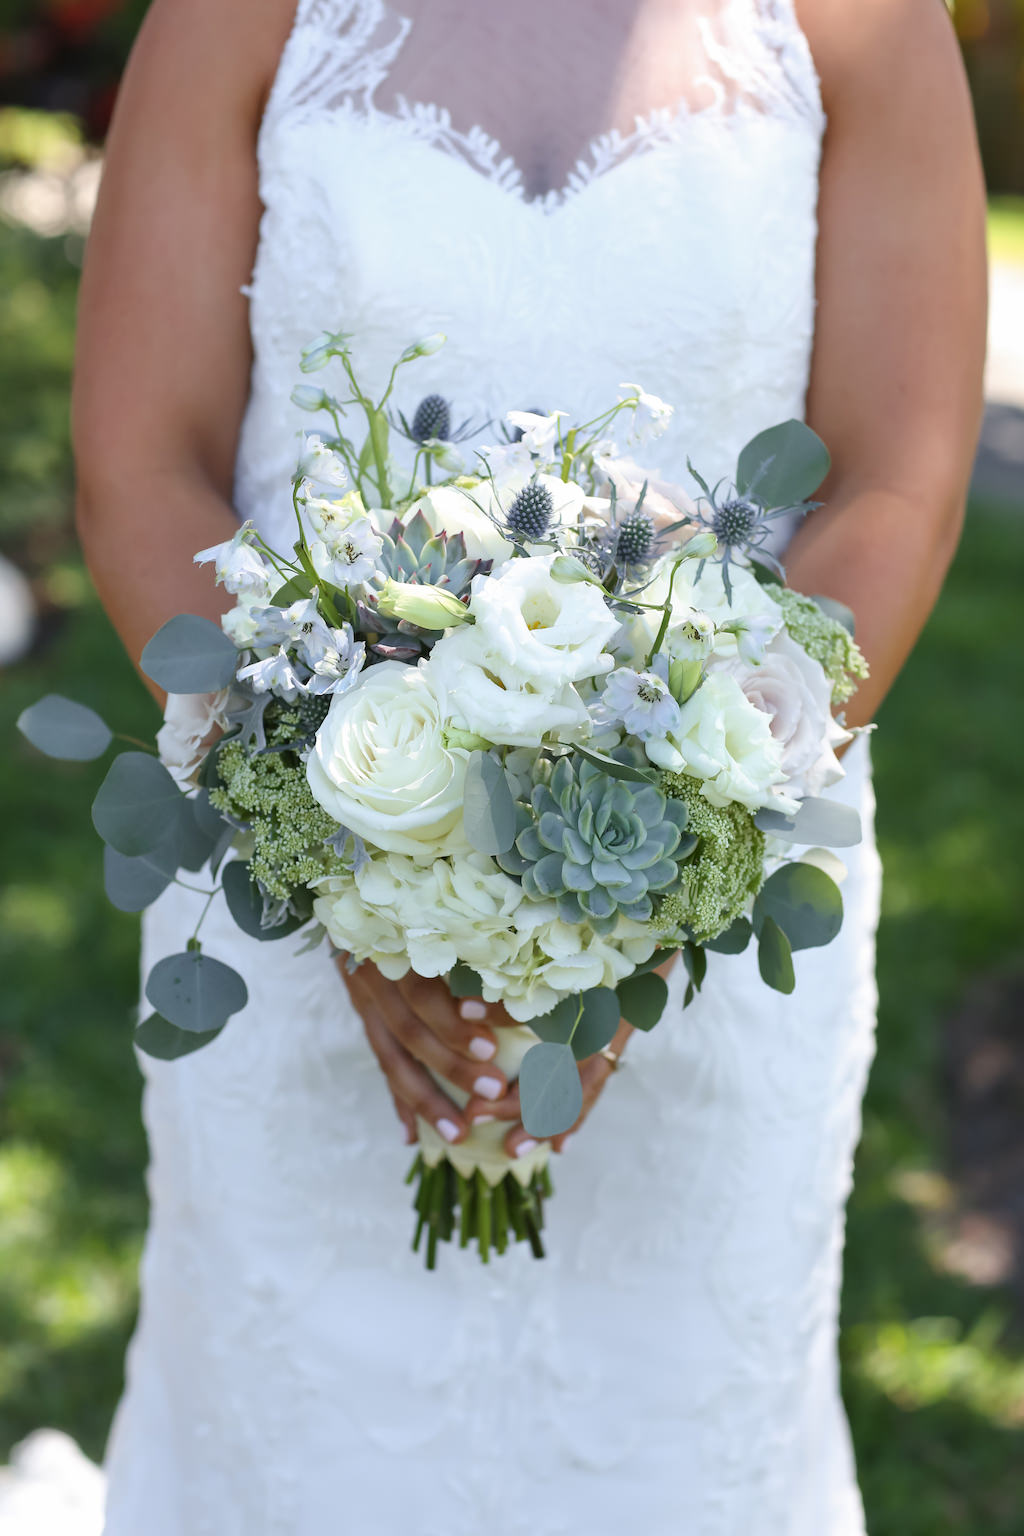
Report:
306,657,467,860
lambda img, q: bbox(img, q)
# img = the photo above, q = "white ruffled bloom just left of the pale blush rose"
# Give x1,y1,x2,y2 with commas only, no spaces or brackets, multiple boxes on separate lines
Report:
645,671,797,811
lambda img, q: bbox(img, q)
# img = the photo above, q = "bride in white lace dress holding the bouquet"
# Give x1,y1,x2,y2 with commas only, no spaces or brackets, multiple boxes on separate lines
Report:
64,0,986,1536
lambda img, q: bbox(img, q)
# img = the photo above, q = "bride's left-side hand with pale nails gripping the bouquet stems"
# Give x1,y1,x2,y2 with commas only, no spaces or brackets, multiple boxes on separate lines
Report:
339,960,509,1143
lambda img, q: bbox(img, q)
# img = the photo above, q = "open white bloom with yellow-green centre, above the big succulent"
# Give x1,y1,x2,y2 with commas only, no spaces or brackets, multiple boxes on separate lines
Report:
470,554,619,687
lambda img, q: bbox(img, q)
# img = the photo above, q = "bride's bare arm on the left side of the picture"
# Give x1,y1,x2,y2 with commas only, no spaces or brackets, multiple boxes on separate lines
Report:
72,0,292,693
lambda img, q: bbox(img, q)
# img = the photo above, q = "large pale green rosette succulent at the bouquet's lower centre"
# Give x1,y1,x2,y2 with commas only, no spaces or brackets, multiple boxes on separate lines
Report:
497,757,695,932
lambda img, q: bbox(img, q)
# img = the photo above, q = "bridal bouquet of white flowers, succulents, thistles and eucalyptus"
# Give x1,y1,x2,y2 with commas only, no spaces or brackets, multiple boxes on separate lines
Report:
20,335,866,1267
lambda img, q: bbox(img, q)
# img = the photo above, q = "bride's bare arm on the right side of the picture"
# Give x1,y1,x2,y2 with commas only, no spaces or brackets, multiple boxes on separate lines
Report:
786,0,986,723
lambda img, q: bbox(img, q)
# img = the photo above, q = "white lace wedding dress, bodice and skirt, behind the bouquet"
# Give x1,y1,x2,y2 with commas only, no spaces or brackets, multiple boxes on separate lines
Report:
90,0,878,1536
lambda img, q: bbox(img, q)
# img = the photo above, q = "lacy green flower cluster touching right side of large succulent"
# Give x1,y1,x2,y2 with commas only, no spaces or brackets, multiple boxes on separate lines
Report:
654,773,765,943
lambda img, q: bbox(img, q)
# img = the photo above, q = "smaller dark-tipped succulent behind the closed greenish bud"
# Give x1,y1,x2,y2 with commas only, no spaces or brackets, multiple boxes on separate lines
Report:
358,511,491,660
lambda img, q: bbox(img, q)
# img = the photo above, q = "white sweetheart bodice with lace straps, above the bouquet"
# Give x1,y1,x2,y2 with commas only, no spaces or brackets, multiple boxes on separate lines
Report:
236,0,823,552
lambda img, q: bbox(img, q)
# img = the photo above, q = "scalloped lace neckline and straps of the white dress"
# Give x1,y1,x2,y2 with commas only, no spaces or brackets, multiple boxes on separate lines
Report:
261,0,824,214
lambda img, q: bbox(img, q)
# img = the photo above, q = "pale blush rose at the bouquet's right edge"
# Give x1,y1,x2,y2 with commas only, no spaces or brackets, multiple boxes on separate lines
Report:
714,630,851,799
